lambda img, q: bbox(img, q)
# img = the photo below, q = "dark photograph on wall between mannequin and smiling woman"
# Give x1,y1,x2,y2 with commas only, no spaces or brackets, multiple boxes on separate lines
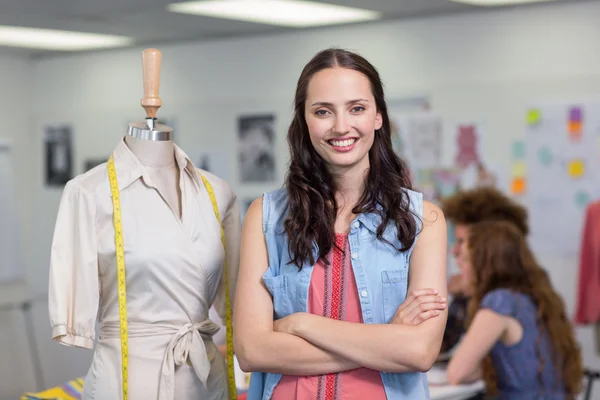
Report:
238,114,276,183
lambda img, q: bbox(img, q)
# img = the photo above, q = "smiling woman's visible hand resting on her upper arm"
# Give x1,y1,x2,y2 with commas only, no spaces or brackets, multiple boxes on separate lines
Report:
390,289,447,325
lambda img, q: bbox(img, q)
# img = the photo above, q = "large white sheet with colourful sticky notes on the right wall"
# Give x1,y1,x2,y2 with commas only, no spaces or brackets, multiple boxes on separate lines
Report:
524,102,600,257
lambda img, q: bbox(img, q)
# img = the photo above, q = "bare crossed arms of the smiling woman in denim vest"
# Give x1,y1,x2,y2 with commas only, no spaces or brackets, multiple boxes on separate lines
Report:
234,199,446,375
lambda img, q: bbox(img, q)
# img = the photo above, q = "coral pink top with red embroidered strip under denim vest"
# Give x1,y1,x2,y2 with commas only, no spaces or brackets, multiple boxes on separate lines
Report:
271,234,386,400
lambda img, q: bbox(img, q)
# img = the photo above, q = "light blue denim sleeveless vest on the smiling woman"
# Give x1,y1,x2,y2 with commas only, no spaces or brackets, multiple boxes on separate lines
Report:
248,188,429,400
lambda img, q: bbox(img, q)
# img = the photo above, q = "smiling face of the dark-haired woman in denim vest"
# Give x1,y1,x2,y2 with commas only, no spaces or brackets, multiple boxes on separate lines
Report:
304,67,382,172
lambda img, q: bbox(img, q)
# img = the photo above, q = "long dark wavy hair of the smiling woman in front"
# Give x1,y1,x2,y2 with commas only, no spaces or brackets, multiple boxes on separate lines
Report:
284,49,417,269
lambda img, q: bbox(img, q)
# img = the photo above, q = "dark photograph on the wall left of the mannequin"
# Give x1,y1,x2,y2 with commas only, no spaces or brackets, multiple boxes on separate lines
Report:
44,125,73,186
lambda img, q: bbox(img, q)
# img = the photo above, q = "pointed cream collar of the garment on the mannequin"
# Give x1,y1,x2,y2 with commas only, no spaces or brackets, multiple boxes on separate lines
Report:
113,138,202,190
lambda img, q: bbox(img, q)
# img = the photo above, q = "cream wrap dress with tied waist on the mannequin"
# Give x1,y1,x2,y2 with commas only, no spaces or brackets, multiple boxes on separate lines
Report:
49,140,240,400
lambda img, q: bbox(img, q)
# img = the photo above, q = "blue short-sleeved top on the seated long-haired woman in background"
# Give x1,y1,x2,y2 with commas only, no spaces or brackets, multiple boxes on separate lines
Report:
481,289,567,400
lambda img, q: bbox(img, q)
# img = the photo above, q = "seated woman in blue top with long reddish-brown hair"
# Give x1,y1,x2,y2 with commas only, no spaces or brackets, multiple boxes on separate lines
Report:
448,221,583,400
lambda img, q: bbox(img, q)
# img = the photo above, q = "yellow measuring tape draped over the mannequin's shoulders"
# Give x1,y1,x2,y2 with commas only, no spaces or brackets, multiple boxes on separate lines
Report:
108,155,237,400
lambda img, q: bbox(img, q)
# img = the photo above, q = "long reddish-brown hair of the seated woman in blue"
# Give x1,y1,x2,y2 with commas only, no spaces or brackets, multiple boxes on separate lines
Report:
468,221,583,400
